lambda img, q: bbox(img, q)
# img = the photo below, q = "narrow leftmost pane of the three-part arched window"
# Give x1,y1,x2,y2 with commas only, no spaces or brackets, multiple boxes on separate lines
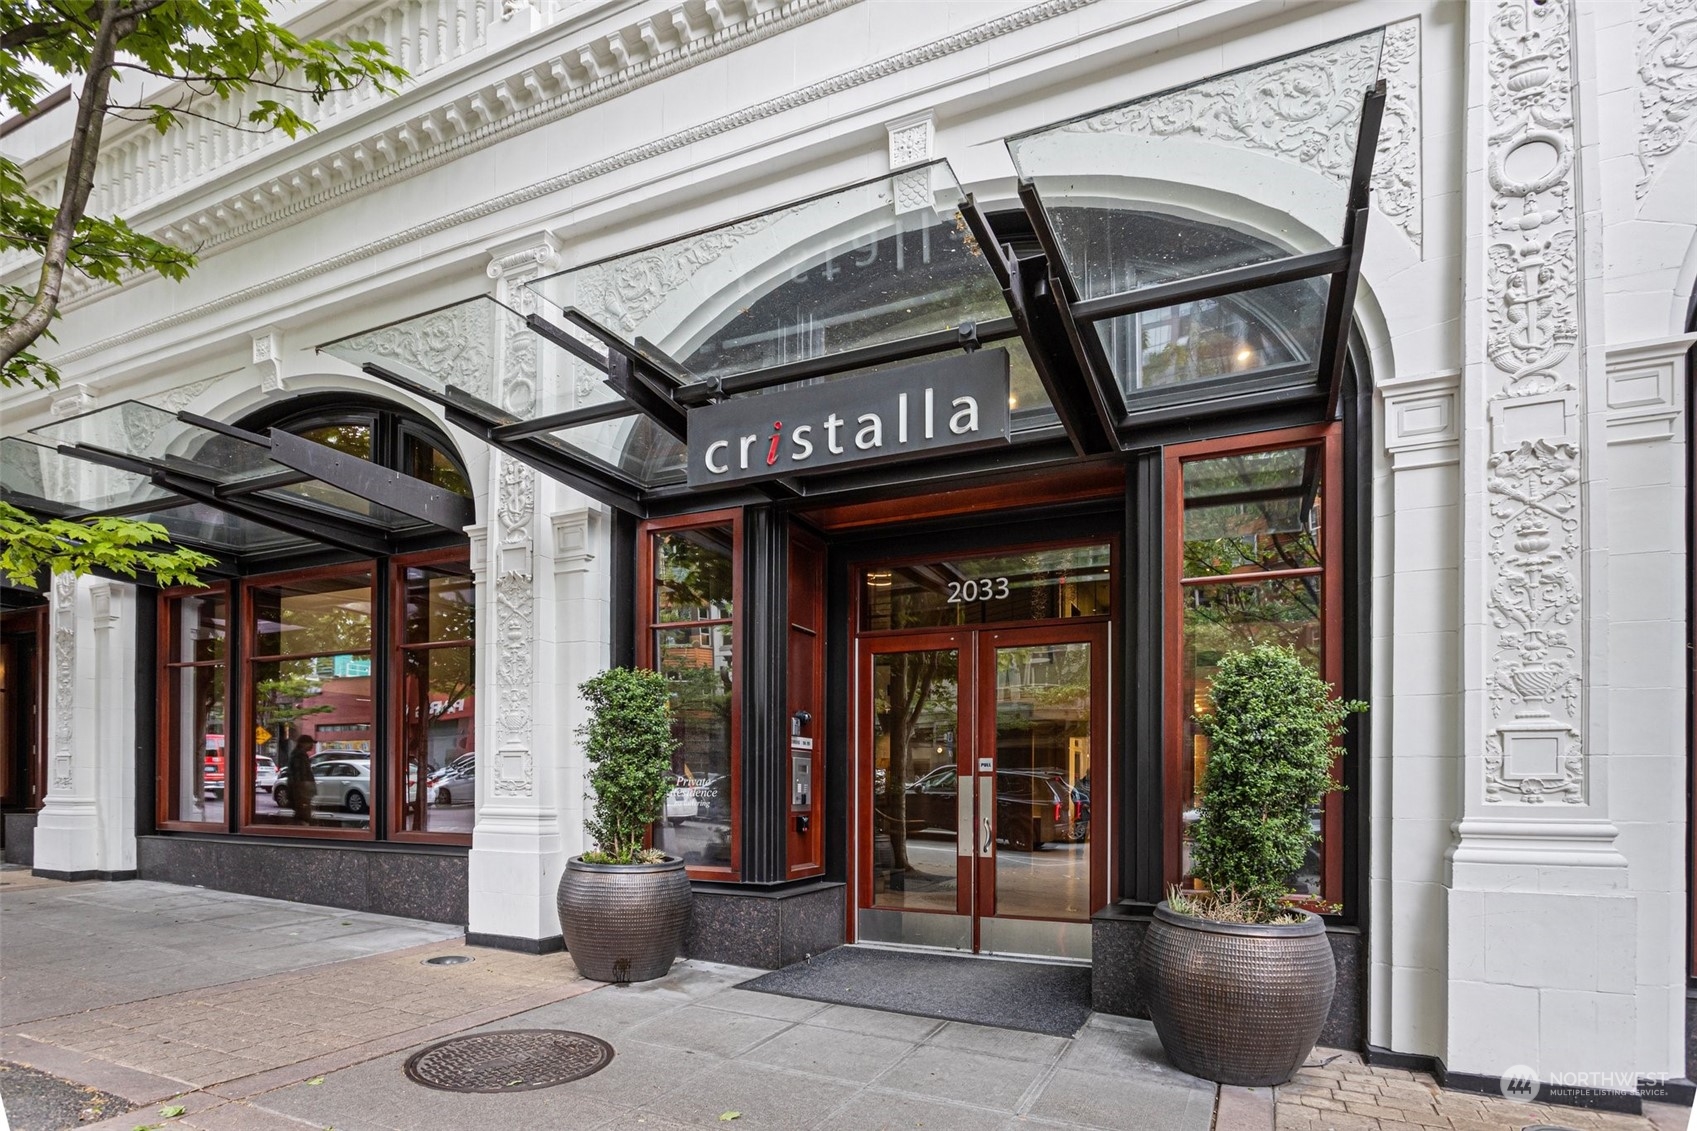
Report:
160,589,231,829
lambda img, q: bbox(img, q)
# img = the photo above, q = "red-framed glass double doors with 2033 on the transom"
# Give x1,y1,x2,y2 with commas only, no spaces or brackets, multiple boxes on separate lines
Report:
854,547,1110,959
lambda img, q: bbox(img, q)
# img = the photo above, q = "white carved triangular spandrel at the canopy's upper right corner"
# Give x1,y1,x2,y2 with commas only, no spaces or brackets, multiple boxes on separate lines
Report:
1066,31,1385,185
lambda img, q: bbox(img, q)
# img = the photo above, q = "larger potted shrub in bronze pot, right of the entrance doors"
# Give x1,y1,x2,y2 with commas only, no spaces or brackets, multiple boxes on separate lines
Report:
1137,645,1366,1087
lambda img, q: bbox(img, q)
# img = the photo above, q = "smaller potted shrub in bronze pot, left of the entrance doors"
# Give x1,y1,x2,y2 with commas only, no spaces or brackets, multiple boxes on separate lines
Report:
558,667,689,983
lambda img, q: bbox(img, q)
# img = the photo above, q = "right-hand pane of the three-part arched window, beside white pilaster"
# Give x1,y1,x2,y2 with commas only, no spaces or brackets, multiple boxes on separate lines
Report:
395,555,477,837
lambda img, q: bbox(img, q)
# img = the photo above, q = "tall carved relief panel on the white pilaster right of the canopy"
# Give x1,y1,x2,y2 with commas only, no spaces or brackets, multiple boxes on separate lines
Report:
1485,0,1587,805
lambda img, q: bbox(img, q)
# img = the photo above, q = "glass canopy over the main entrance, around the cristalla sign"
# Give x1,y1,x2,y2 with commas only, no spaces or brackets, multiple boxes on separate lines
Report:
321,40,1385,515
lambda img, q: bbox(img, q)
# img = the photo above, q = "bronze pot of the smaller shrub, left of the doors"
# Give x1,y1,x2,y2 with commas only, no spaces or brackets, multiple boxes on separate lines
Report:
555,856,689,983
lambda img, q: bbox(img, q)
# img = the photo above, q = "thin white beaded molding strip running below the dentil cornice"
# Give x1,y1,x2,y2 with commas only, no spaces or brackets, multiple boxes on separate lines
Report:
53,0,1096,365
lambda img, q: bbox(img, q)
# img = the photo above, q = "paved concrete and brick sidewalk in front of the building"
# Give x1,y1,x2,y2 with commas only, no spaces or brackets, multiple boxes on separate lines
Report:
0,873,1687,1131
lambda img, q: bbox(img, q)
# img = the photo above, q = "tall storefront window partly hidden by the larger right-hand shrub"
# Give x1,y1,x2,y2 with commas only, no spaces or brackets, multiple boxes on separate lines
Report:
1168,431,1341,902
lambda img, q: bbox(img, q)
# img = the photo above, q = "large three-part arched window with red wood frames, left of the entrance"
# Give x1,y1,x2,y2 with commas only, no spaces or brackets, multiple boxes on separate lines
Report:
156,394,477,844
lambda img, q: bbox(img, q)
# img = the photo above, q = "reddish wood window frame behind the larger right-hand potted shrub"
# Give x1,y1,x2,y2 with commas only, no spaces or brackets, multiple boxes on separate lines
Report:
1162,423,1354,912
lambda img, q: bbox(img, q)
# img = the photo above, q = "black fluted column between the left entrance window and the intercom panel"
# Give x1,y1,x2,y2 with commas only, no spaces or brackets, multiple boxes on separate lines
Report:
736,506,789,883
